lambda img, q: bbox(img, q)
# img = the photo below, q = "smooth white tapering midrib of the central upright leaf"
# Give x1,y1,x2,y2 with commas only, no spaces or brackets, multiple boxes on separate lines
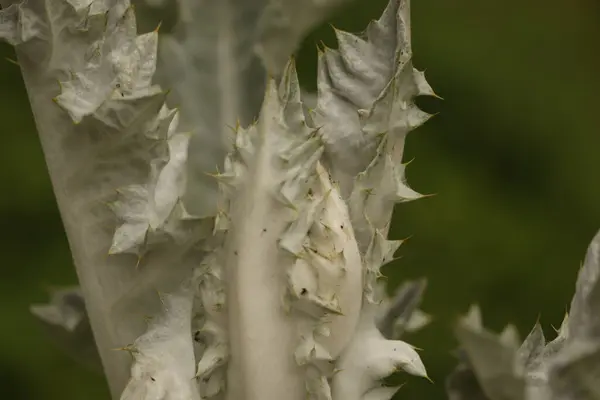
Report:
226,79,305,400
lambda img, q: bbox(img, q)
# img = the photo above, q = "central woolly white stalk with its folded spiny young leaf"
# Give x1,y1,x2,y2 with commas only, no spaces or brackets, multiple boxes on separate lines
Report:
219,65,362,400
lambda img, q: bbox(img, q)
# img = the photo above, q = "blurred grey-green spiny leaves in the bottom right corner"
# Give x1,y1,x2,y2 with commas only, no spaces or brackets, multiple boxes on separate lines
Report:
447,232,600,400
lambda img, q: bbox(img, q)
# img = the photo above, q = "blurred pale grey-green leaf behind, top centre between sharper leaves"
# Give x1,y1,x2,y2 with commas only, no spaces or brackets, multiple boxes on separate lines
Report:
152,0,358,216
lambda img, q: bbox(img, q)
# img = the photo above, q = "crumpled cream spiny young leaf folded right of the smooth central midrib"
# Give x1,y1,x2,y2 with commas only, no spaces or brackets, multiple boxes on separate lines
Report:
280,165,362,400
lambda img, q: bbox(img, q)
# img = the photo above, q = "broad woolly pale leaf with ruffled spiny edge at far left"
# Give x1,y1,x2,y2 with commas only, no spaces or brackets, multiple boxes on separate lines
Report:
0,0,202,398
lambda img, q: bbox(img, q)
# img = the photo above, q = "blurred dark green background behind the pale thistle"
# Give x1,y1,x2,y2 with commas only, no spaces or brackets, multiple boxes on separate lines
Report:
0,0,600,400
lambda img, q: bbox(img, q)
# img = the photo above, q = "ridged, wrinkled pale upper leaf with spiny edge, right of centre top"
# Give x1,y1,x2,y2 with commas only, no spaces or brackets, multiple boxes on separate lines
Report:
315,0,434,200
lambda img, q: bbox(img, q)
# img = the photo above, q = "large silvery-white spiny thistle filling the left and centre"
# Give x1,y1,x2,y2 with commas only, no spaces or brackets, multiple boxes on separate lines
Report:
0,0,434,400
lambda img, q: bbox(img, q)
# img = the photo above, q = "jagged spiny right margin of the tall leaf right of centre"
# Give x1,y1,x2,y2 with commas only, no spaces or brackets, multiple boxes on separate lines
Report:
349,50,433,306
